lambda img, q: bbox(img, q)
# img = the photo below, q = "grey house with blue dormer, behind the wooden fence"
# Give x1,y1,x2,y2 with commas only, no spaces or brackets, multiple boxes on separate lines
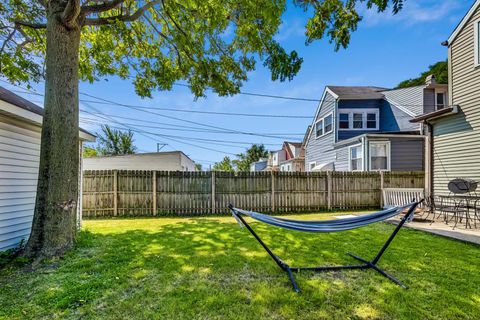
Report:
305,81,448,171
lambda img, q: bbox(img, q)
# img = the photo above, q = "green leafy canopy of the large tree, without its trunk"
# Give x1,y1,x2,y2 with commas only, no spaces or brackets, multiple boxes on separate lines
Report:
0,0,405,96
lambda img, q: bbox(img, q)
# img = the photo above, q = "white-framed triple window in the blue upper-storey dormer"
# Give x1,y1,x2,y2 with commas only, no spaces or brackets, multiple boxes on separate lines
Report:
338,109,379,130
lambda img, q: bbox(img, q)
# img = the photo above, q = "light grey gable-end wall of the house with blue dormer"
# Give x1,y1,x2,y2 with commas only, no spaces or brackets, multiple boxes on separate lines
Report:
305,92,337,171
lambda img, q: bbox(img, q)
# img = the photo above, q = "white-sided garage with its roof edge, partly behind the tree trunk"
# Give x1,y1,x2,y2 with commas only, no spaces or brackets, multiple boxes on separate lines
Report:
0,87,95,251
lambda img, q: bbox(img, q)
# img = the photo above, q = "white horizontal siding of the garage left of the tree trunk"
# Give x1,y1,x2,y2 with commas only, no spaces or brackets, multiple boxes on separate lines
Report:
0,116,40,251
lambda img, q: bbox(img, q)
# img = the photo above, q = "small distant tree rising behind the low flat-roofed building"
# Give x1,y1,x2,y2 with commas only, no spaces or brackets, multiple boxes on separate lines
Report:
97,126,137,156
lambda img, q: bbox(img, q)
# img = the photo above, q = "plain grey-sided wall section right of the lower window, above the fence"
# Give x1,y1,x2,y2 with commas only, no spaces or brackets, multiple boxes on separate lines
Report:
390,138,425,171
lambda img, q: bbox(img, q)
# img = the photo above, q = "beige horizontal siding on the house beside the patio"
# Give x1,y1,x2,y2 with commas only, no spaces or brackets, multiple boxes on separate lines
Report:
433,9,480,194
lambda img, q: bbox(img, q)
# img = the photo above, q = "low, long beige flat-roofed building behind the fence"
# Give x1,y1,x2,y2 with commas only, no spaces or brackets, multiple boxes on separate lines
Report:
83,151,197,171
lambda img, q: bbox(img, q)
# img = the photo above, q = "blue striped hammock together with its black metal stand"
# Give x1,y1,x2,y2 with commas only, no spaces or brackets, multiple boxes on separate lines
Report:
229,200,423,292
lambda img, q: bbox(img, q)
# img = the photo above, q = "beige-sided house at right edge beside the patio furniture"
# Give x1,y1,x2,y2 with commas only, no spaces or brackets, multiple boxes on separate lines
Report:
413,0,480,194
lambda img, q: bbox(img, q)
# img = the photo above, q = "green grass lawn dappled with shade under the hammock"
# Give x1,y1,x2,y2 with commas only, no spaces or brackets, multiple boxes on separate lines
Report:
0,215,480,319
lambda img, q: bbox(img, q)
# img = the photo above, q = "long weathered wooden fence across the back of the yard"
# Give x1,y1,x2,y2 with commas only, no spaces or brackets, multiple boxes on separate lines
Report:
82,170,424,217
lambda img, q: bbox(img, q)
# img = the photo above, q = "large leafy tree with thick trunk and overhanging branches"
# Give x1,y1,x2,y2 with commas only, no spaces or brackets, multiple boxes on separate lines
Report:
0,0,405,259
